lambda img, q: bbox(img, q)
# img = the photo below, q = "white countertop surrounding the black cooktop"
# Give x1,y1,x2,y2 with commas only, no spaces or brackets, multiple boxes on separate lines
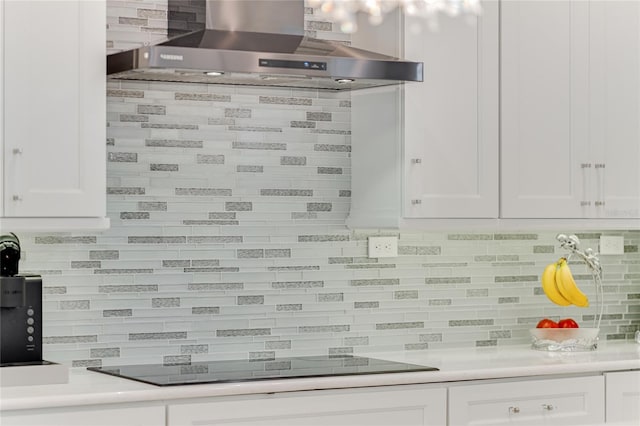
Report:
0,341,640,410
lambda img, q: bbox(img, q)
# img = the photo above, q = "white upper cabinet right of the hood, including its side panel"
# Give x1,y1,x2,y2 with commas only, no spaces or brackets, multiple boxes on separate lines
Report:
348,1,499,227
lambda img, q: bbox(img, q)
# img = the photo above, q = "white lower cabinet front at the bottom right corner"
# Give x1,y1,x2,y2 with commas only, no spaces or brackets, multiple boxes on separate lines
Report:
605,371,640,424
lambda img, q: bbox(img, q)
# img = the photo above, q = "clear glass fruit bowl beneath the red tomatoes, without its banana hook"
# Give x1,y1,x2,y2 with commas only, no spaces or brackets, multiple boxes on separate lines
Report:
529,328,600,352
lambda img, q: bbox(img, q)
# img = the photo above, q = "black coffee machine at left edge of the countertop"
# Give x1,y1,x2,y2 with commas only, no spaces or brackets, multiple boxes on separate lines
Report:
0,233,42,365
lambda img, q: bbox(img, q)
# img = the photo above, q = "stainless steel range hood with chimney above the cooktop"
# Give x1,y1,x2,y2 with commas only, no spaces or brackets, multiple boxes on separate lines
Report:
107,0,423,90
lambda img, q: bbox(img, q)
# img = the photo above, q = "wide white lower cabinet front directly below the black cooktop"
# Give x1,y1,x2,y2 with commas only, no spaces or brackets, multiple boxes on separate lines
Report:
167,385,447,426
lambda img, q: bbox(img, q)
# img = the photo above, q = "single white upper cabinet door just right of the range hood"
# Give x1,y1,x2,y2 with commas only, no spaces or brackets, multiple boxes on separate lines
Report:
403,1,499,218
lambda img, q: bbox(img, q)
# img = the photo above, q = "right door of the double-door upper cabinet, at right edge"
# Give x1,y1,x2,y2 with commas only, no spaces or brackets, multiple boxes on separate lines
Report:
589,1,640,218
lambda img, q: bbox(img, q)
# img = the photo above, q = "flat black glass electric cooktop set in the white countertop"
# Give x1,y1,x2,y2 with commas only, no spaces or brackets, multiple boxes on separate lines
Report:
87,355,438,386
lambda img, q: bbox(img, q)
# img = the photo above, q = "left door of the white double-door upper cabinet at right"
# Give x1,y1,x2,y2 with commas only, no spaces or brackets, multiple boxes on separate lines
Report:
500,1,593,218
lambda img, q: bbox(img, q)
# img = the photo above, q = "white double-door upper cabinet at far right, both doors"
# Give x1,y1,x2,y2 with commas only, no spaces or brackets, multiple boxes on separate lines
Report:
501,0,640,218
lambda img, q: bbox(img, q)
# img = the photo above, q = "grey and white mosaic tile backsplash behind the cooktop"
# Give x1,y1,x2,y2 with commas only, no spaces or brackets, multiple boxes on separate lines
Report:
15,1,640,366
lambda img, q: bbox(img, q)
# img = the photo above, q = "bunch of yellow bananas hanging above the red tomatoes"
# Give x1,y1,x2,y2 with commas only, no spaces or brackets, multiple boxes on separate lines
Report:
542,257,589,308
